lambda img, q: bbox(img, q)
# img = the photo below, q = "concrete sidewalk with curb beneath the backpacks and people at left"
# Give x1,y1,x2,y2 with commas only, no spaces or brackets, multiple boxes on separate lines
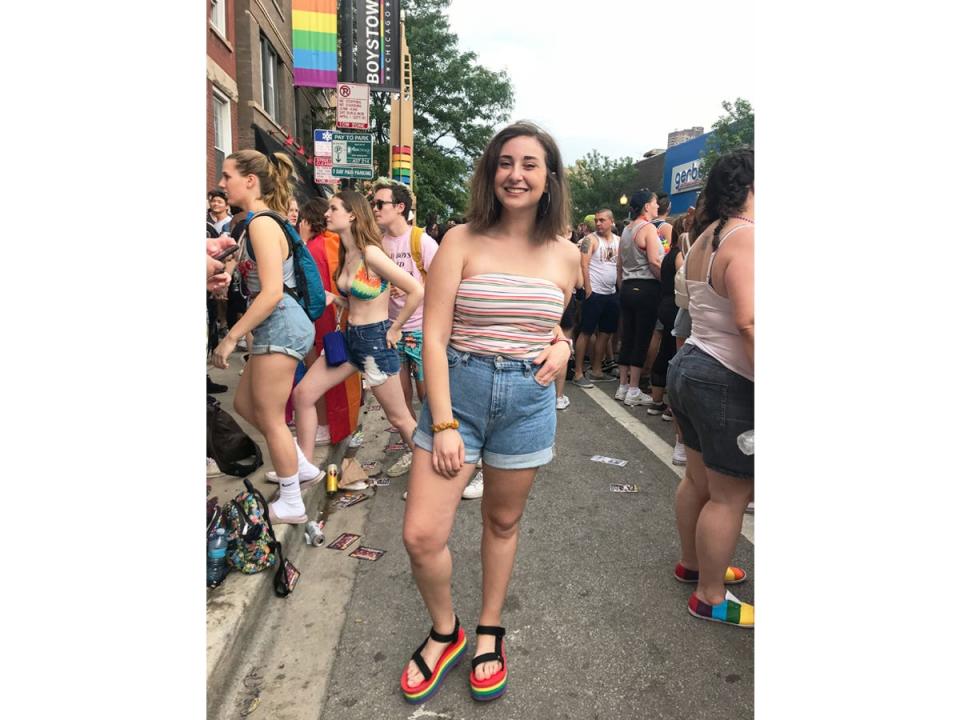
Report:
206,352,364,707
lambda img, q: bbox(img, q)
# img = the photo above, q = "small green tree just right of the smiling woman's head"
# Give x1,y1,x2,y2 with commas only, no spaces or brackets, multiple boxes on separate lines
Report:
567,150,640,227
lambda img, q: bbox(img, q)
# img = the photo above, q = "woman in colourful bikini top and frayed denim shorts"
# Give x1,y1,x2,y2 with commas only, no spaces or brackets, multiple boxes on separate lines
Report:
293,190,423,462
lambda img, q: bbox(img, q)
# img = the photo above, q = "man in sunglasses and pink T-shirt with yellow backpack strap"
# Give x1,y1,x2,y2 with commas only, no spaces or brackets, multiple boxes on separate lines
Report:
370,180,437,477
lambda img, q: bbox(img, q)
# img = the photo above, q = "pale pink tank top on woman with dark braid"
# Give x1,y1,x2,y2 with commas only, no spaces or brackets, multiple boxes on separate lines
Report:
687,223,753,382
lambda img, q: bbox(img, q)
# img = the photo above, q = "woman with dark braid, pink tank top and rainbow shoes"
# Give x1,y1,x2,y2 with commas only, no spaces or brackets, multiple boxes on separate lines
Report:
667,150,753,628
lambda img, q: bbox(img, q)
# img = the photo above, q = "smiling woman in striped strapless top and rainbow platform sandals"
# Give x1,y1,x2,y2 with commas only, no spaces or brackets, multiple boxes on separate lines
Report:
400,122,580,703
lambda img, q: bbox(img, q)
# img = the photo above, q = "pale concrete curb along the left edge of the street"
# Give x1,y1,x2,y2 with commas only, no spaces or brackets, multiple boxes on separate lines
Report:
206,434,352,715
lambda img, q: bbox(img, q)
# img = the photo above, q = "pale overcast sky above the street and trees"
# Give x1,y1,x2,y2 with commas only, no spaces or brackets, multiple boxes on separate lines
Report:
446,0,756,165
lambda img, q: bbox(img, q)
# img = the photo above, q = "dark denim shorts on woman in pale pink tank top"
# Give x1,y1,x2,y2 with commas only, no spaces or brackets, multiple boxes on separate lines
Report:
667,342,754,480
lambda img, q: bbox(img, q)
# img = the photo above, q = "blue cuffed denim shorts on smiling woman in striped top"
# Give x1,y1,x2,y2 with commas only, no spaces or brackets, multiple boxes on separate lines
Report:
413,347,557,470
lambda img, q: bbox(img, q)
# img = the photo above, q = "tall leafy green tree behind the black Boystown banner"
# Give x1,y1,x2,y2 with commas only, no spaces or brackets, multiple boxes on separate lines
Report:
370,0,513,223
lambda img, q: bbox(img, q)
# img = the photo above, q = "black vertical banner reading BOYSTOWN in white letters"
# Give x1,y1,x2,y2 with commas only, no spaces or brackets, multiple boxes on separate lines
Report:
352,0,400,93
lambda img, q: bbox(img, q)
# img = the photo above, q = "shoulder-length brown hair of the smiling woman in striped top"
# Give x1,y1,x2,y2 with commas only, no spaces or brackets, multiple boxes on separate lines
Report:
467,121,570,244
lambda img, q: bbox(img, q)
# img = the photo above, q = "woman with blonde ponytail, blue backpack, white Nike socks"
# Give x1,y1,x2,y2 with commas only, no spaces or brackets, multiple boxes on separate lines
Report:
213,150,331,523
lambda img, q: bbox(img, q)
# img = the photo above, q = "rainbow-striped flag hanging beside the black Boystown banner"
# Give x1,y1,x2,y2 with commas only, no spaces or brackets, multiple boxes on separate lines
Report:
293,0,337,87
